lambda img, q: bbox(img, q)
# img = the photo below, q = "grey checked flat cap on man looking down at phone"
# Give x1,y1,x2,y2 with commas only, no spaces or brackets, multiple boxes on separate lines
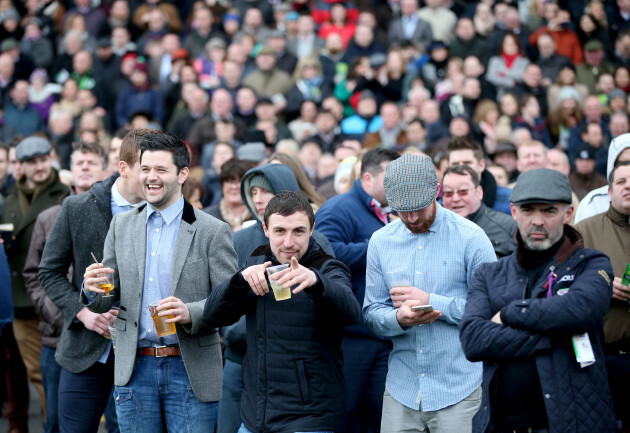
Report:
384,154,438,212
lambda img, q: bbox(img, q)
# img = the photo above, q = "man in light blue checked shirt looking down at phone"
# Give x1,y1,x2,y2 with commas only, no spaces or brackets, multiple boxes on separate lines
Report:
363,154,496,433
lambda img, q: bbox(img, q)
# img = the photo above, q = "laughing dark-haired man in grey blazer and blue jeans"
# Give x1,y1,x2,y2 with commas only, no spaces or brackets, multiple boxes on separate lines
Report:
81,131,237,433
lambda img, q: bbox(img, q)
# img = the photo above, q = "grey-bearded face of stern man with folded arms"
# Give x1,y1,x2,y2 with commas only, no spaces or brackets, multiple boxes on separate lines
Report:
510,203,573,251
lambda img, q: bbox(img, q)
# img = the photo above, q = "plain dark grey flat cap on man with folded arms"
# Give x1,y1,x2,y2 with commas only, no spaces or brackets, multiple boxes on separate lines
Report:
510,168,572,206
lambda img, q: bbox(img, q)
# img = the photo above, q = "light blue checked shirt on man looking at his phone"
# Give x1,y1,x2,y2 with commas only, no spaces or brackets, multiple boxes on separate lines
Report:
363,204,496,411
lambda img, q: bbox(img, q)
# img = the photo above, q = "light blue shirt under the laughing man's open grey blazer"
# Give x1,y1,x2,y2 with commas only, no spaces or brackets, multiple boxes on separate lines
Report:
138,196,184,347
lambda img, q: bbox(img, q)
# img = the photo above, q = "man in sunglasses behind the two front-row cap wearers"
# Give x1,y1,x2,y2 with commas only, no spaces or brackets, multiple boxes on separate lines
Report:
442,165,516,258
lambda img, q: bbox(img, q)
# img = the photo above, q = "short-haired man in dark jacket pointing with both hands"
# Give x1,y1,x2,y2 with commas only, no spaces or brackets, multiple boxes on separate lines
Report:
204,191,360,433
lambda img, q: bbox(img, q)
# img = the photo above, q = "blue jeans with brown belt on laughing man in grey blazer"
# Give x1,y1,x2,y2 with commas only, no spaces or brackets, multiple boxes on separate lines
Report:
114,355,219,433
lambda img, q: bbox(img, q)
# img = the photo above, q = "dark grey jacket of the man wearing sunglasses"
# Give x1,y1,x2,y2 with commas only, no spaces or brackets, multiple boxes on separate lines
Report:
468,203,516,259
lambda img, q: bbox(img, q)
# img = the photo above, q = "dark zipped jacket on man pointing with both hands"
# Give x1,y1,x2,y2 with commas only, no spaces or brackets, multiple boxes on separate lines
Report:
204,238,360,433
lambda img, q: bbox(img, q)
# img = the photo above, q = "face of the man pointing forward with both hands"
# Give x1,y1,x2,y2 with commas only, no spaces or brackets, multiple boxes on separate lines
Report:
263,212,313,264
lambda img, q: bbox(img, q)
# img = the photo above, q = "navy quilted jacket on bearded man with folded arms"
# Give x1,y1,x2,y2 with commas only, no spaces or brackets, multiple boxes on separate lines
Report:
460,226,615,433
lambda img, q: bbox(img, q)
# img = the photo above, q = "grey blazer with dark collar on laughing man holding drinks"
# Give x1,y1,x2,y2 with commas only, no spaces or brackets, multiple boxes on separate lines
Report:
81,202,238,402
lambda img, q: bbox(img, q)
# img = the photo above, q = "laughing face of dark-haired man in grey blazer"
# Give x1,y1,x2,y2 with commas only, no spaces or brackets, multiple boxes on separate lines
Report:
140,150,188,211
